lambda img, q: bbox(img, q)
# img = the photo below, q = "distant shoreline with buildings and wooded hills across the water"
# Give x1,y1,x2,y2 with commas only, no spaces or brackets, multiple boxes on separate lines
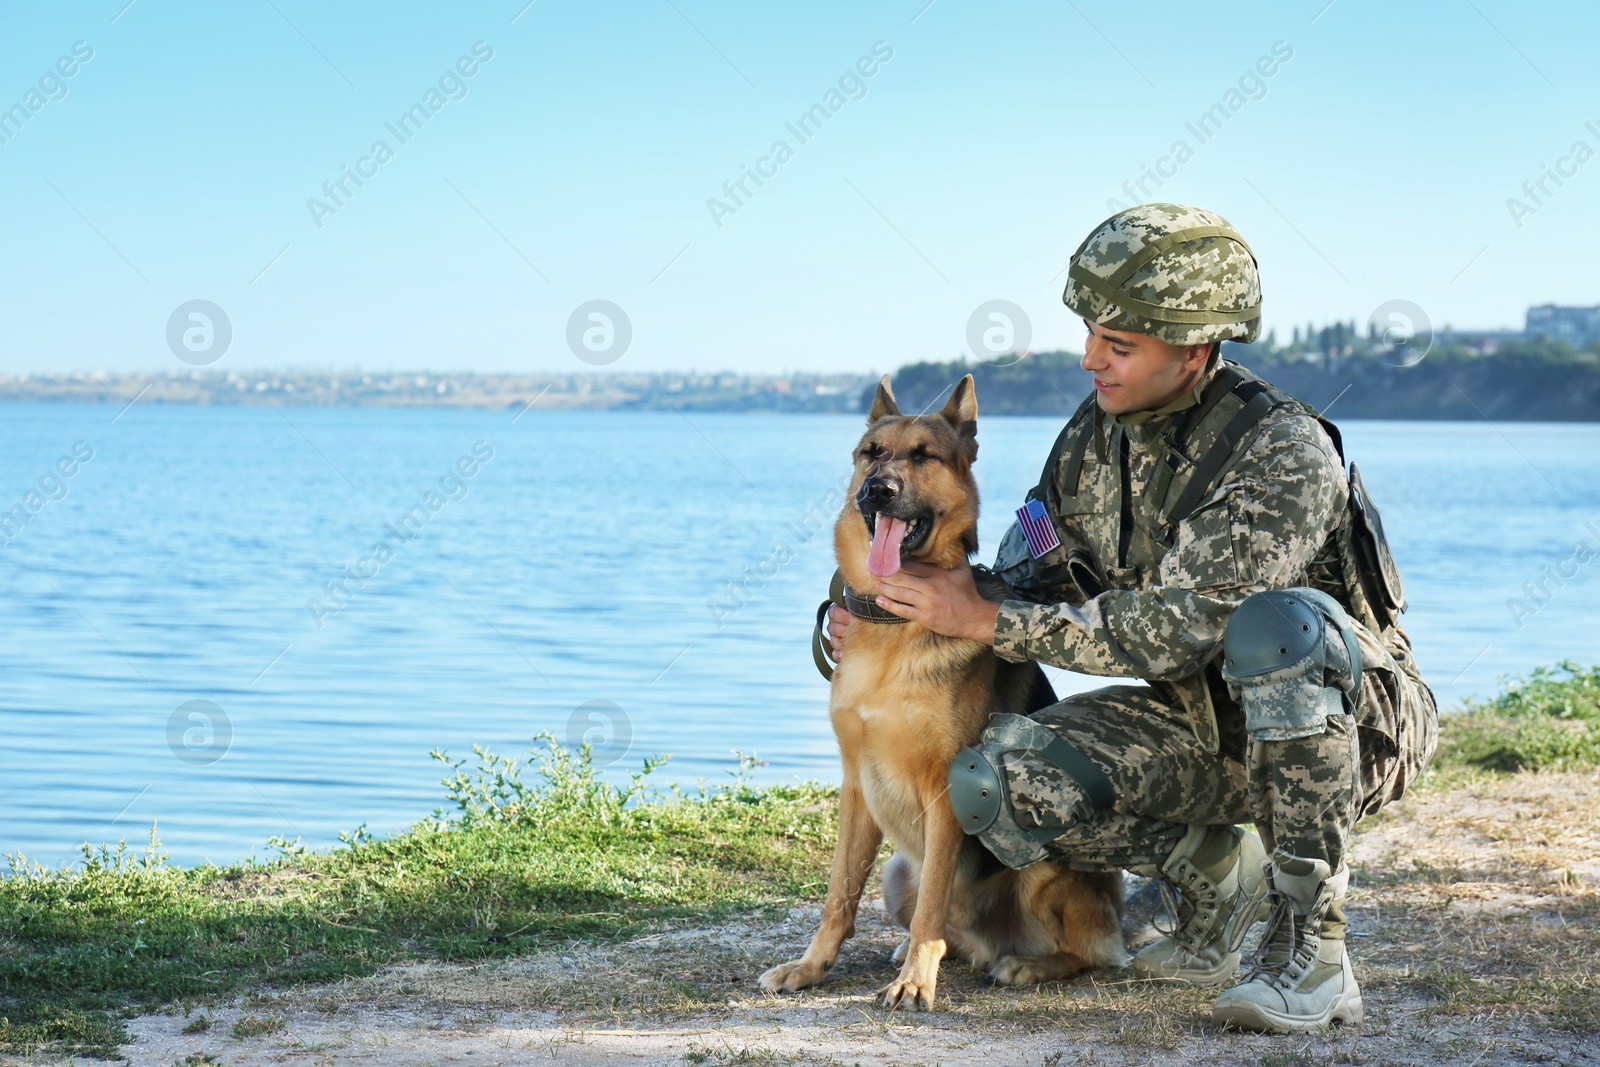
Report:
0,344,1600,422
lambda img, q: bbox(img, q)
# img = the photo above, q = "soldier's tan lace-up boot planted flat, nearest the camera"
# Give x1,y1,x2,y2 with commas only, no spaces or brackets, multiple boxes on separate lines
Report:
1211,853,1362,1033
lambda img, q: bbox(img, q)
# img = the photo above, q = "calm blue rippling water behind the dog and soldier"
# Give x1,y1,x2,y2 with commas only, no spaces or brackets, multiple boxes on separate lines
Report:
0,405,1600,865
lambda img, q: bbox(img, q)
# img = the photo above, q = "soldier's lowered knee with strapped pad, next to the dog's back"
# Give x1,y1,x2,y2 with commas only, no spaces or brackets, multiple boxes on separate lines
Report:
949,715,1114,867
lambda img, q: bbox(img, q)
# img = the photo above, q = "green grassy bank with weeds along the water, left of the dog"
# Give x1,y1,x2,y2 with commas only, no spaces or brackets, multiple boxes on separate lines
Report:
0,734,837,1056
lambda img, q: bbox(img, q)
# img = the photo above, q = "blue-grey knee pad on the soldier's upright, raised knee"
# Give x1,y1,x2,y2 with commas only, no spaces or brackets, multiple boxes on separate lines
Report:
1222,589,1362,741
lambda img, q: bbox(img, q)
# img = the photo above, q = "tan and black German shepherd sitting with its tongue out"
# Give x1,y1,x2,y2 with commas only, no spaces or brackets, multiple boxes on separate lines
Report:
760,374,1126,1011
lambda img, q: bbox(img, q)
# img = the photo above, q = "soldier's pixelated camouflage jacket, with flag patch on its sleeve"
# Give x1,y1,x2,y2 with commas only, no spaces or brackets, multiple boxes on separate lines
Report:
994,363,1365,750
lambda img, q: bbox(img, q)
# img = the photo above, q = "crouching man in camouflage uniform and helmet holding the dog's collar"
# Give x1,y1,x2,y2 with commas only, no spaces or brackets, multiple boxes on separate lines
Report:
829,205,1437,1032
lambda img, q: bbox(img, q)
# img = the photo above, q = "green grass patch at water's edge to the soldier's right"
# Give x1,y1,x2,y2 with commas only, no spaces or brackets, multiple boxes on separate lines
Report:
1434,661,1600,776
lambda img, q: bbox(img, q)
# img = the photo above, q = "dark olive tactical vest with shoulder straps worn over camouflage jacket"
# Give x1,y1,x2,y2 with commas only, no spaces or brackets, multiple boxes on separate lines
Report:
997,360,1405,752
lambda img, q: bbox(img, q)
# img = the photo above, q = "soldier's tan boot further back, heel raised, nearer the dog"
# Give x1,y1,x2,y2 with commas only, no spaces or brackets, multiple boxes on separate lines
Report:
1133,825,1267,985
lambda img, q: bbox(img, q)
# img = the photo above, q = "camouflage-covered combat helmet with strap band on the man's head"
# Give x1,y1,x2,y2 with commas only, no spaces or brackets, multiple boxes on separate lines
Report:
1061,203,1261,346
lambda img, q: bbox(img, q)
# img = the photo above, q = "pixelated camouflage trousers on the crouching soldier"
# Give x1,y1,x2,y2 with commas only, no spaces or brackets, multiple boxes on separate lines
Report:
979,625,1438,870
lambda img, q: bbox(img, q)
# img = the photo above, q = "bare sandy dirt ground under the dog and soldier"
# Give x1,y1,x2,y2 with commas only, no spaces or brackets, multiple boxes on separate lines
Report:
15,773,1600,1067
